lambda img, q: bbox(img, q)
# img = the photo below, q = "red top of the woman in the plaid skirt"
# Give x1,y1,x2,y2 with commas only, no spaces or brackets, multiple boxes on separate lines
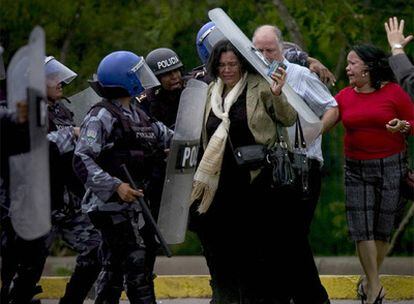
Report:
335,83,414,160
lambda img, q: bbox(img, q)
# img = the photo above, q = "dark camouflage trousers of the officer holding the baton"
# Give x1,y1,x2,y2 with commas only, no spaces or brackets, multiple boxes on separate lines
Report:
95,217,155,304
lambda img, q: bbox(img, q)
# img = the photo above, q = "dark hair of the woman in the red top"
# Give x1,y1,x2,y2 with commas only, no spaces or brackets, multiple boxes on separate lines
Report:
351,44,395,90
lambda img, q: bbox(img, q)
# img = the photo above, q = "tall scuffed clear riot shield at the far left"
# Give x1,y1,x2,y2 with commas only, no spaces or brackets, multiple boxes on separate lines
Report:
7,27,51,240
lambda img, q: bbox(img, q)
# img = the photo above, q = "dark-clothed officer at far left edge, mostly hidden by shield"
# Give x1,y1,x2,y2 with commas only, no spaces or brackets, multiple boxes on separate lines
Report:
0,42,47,304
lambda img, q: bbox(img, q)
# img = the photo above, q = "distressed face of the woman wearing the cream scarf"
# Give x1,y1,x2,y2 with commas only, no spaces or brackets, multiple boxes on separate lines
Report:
218,51,242,88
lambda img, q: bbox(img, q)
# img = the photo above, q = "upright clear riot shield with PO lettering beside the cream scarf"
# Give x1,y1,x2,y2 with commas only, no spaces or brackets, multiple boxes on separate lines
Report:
158,79,207,244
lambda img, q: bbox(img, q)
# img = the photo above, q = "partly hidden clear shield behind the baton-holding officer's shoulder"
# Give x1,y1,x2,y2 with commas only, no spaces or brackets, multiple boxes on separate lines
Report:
64,87,102,126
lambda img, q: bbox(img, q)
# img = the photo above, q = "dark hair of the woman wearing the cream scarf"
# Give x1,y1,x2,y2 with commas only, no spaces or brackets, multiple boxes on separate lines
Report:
206,39,256,79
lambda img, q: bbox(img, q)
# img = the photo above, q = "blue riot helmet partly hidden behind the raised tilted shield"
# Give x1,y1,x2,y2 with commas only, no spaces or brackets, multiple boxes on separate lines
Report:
196,21,225,64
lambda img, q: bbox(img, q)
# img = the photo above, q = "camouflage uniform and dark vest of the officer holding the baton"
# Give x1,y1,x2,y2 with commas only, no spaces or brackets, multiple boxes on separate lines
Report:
74,99,172,304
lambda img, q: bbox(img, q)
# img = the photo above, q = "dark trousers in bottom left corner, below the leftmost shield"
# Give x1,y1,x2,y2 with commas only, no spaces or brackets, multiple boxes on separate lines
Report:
1,218,47,304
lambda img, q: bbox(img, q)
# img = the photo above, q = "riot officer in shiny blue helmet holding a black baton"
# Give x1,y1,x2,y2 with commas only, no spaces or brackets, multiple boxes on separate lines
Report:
74,51,172,304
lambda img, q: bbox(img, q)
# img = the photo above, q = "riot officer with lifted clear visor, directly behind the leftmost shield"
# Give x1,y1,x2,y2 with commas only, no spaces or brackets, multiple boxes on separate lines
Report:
45,56,101,304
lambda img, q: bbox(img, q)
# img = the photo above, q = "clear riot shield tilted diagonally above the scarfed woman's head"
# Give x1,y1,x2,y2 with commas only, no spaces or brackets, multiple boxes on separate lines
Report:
208,8,322,144
